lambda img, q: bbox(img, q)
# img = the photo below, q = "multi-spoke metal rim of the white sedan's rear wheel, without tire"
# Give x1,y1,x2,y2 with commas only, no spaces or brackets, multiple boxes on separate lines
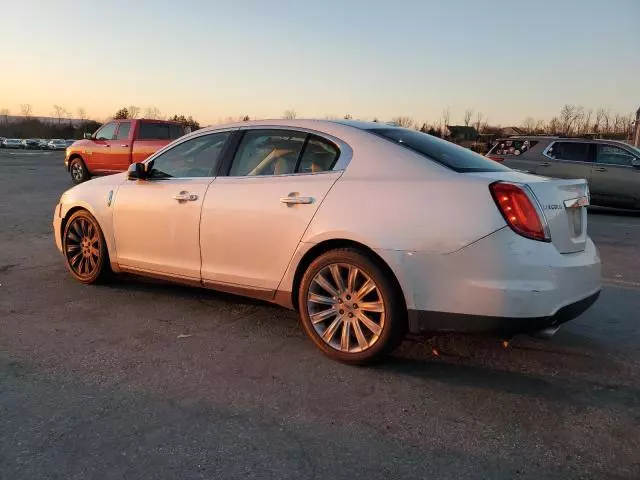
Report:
307,263,385,353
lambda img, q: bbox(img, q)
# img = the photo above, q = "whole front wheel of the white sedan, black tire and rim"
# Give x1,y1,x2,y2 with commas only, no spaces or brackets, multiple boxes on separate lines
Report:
62,210,111,284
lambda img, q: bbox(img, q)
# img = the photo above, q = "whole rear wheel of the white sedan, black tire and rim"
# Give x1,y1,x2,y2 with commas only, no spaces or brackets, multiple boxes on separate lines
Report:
298,248,407,365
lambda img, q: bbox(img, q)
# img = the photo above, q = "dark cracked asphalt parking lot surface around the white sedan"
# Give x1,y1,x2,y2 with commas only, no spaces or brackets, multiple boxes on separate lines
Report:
0,150,640,479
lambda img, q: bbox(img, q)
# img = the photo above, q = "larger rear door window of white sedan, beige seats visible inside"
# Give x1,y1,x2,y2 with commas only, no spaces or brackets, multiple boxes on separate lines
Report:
229,130,307,177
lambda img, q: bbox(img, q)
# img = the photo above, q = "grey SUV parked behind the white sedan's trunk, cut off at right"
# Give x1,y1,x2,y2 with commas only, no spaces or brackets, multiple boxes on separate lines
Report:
487,136,640,208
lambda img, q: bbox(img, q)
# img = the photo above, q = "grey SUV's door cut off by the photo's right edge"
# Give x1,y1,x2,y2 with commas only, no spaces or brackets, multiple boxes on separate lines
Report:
591,144,640,207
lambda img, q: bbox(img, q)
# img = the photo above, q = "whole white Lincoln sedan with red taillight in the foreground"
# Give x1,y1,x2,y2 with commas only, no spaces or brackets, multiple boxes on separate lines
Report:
53,120,601,363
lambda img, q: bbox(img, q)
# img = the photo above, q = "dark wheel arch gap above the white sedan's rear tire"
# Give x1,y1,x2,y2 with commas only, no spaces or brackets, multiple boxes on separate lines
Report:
291,238,407,311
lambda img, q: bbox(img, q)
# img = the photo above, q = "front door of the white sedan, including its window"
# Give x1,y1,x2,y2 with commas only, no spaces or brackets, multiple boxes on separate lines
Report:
113,132,230,282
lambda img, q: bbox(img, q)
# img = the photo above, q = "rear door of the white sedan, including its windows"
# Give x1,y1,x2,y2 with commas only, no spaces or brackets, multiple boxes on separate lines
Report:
200,129,342,297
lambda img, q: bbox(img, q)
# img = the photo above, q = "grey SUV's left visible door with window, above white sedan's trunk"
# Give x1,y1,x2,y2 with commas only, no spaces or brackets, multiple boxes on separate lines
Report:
534,141,593,183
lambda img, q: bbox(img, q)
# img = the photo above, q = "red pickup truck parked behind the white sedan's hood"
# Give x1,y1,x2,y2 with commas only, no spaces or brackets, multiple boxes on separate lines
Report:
64,119,187,183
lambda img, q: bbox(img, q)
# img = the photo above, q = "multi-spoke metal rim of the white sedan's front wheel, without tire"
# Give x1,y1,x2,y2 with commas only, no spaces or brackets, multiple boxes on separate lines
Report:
64,217,101,277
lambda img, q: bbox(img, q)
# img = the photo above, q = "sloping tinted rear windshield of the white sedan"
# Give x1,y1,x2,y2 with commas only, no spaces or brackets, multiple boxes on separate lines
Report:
368,128,510,172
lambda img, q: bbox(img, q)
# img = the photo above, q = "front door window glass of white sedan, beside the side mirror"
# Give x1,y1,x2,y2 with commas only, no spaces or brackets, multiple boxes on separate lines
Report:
151,132,230,178
